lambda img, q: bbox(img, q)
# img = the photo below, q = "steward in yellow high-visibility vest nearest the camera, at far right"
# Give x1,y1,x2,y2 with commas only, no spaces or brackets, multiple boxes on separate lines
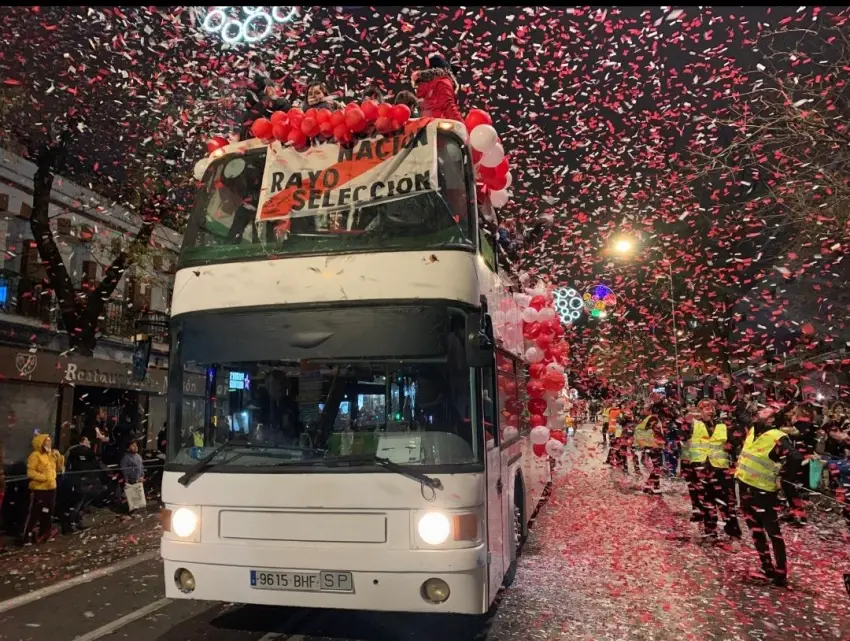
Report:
735,407,802,586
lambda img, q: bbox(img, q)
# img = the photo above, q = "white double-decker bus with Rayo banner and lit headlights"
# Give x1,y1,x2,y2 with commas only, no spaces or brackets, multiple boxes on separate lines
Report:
162,120,550,614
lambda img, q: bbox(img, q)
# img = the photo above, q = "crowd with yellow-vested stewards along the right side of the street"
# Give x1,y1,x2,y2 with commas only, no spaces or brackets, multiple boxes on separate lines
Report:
588,394,850,586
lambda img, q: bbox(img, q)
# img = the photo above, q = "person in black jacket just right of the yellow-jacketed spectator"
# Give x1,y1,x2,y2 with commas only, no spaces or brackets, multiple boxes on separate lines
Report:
60,436,104,534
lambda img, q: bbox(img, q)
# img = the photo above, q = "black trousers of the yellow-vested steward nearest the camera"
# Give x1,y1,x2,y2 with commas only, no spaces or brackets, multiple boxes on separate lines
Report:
738,481,788,576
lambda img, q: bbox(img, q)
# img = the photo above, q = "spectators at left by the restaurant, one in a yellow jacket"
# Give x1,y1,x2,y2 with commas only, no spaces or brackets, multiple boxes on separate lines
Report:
0,410,158,551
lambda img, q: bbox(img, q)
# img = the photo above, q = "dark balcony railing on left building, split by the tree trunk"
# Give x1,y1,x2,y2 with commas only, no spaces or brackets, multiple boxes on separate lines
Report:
0,272,168,343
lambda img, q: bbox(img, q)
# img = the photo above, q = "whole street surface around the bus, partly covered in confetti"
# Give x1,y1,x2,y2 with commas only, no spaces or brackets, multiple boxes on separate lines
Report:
0,429,850,641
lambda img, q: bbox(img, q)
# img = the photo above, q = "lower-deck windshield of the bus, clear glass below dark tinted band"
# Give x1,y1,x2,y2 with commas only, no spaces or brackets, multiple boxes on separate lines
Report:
168,360,480,471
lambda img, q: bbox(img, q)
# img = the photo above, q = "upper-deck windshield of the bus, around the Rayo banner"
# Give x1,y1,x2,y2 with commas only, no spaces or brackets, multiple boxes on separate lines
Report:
180,132,475,267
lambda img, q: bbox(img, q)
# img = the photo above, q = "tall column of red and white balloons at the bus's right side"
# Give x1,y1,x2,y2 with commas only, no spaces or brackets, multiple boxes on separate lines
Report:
506,285,569,459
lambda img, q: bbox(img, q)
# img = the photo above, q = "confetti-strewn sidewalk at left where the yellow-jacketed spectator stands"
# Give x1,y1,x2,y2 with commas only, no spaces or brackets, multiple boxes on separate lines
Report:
0,504,161,601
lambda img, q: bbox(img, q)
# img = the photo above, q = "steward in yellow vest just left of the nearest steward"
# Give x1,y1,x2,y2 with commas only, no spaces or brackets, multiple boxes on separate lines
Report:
688,399,741,539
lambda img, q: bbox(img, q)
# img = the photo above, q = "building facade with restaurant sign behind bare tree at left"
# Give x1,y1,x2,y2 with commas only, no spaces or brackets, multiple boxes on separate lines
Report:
0,149,181,465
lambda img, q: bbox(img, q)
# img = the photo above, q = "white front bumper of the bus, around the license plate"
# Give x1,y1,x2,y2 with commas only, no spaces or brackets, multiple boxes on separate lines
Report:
162,540,489,614
